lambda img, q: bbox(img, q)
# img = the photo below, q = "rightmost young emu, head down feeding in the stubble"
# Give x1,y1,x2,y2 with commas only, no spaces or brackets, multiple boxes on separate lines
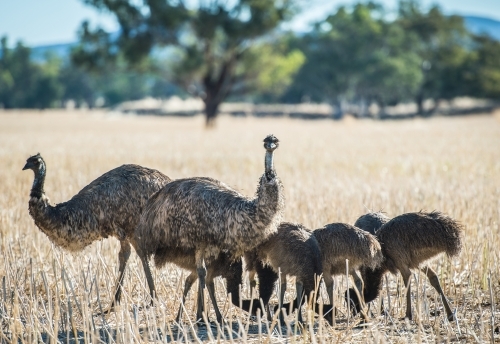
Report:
346,211,463,320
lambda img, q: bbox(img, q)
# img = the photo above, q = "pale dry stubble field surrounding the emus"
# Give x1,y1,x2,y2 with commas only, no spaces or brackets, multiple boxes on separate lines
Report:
0,111,500,343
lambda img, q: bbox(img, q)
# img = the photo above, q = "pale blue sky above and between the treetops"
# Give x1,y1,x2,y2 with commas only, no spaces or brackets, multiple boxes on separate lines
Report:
0,0,500,46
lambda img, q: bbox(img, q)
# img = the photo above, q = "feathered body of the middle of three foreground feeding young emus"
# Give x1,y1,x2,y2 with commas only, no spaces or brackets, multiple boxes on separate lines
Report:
313,223,383,275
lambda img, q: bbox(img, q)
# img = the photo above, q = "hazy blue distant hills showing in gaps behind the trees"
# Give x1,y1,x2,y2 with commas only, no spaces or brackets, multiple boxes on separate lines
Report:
31,16,500,61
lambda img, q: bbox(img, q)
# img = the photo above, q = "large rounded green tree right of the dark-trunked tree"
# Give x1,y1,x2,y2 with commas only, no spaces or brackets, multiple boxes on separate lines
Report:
288,2,422,117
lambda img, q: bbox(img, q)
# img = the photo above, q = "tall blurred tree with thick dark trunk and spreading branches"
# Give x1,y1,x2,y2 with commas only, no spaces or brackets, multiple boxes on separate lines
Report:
74,0,295,126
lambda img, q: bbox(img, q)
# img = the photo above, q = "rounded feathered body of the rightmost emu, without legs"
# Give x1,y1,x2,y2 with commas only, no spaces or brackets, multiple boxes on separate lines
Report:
376,211,462,273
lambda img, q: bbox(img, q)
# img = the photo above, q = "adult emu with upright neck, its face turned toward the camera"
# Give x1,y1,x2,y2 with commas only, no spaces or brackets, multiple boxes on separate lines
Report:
133,135,284,319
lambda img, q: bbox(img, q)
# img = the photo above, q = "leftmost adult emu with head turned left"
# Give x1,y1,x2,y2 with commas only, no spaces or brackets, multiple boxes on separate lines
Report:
23,153,170,310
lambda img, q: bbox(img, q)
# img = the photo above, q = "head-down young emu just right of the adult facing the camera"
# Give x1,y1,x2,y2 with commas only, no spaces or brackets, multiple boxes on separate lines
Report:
243,222,322,323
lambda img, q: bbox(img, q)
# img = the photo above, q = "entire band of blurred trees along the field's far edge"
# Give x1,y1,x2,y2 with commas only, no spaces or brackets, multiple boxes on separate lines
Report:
0,0,500,118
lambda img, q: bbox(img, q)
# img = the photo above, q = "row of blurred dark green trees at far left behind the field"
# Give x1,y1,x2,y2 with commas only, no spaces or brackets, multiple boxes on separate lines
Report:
0,34,179,109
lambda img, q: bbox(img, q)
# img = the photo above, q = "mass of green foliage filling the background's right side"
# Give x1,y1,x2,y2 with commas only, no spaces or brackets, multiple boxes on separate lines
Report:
283,0,500,113
